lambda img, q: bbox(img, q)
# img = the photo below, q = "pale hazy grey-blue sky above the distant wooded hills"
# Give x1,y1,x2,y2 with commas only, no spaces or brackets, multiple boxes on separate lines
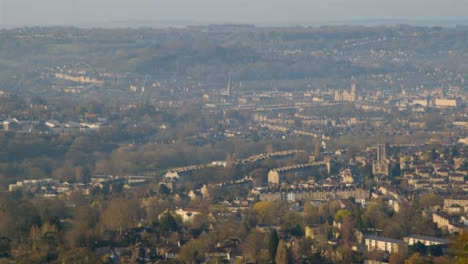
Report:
0,0,468,25
